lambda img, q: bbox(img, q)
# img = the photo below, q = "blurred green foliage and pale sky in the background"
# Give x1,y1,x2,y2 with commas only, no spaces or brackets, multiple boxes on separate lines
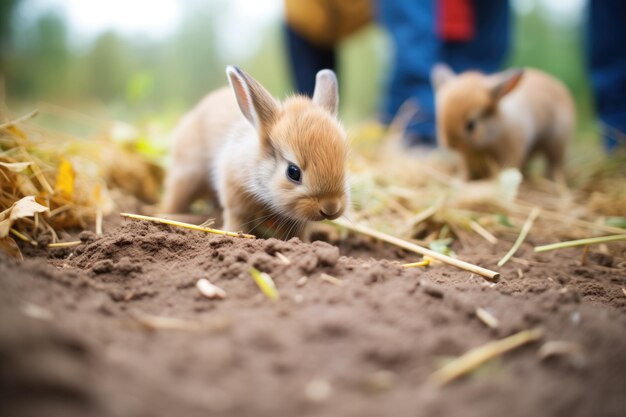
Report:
0,0,594,140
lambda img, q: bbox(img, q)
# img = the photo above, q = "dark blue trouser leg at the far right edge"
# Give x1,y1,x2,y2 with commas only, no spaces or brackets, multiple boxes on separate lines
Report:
587,0,626,151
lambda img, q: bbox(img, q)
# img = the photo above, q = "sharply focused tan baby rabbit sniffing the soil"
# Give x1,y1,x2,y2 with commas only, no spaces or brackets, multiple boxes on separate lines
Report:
162,66,349,239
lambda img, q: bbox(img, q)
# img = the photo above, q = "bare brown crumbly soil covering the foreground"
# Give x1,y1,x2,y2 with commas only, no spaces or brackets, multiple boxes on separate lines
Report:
0,221,626,417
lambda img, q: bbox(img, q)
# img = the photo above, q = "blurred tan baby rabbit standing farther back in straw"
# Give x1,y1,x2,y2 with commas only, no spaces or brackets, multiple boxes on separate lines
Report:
431,64,575,183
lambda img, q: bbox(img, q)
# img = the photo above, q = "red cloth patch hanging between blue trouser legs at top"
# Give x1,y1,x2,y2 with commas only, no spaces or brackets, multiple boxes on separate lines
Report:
437,0,475,42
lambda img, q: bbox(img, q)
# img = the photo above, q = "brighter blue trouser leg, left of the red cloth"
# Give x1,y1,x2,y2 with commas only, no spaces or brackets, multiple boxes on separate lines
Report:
377,0,439,145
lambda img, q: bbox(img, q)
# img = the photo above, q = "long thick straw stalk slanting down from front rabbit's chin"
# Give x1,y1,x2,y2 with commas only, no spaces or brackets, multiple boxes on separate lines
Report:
333,218,500,281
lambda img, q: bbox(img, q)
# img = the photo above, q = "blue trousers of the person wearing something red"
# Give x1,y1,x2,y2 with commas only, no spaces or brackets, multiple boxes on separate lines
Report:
376,0,508,145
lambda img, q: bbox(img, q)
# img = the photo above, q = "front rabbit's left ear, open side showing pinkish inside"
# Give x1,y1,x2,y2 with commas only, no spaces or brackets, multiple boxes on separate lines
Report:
226,66,279,136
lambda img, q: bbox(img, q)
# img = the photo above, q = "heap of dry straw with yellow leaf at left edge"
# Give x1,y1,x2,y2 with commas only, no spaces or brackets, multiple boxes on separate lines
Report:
0,111,123,258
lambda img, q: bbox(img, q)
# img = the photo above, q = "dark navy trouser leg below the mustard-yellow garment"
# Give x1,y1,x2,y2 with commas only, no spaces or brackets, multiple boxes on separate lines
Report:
285,25,336,97
